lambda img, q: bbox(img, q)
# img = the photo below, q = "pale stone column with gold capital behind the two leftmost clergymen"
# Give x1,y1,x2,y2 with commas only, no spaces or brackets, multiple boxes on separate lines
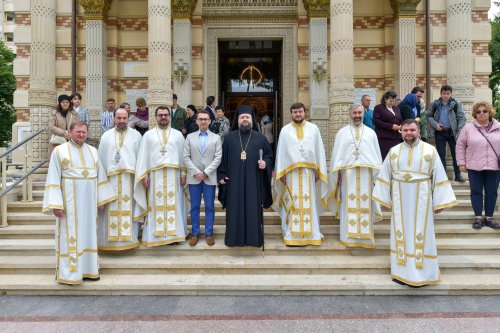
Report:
80,0,112,145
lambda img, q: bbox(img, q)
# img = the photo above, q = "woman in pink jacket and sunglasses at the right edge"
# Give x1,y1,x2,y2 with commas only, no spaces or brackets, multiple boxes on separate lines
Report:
456,102,500,229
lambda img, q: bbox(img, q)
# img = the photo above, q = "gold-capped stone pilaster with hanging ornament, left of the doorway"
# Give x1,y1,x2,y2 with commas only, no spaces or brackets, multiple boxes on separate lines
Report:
172,0,196,108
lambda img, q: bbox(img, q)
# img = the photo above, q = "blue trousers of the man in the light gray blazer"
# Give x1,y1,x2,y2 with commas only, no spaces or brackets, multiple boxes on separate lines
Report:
189,182,215,236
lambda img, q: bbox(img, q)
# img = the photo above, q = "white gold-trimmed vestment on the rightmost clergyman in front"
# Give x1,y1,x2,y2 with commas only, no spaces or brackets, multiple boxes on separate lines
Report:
373,141,457,286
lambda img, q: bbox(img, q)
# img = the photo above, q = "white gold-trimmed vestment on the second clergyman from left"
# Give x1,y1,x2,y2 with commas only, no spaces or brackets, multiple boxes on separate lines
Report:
97,128,142,250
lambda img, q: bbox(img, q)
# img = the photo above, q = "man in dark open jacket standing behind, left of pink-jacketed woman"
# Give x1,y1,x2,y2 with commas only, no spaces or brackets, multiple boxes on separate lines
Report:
427,85,465,183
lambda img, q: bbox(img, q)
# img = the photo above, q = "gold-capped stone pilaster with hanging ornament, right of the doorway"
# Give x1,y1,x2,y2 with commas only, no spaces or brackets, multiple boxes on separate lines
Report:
304,0,330,149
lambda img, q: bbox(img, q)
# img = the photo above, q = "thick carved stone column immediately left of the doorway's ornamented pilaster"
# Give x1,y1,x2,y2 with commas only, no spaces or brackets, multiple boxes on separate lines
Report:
147,0,172,128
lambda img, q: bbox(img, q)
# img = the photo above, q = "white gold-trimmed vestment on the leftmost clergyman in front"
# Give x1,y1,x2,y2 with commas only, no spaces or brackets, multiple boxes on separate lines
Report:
43,141,116,284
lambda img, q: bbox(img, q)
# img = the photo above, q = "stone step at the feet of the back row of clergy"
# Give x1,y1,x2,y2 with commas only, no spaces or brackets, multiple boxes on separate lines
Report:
0,234,500,256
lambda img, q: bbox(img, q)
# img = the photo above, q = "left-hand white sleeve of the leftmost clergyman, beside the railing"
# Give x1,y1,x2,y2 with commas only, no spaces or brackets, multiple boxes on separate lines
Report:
42,148,64,214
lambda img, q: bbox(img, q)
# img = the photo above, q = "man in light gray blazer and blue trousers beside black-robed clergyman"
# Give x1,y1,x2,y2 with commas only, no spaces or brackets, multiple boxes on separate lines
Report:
184,110,222,246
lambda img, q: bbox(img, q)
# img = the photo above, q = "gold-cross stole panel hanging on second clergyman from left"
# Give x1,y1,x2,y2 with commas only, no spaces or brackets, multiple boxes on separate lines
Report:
108,172,134,242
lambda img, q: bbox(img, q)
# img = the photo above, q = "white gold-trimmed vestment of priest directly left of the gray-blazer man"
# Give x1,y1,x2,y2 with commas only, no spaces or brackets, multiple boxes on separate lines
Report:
134,127,187,246
